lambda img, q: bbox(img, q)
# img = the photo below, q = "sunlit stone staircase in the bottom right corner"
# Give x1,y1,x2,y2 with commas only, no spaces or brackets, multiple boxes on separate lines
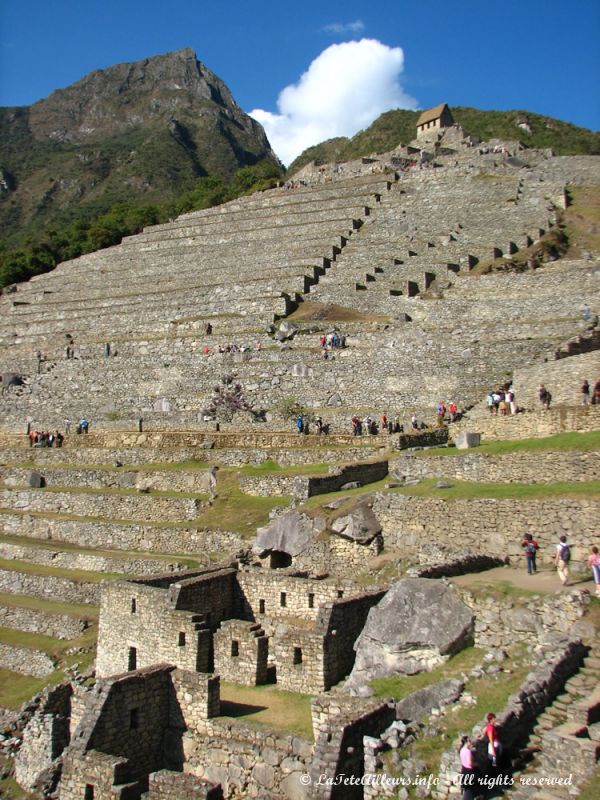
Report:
504,639,600,800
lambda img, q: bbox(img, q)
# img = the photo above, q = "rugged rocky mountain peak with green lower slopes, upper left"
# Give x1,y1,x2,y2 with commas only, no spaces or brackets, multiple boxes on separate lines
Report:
0,49,279,242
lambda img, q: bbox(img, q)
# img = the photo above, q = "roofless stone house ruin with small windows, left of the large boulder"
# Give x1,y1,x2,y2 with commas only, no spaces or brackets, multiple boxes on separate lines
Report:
96,565,383,694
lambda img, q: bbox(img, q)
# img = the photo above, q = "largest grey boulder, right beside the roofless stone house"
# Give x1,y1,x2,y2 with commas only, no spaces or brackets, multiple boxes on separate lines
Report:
346,578,474,691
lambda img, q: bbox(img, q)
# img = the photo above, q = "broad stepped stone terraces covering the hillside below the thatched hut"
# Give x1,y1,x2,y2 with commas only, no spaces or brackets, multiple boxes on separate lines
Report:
0,151,600,430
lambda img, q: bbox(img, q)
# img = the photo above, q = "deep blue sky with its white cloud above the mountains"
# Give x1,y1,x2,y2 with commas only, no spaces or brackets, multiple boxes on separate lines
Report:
0,0,600,162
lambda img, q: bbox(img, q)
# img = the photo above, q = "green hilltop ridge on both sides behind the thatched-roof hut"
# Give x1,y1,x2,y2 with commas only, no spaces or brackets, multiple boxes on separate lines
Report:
288,106,600,174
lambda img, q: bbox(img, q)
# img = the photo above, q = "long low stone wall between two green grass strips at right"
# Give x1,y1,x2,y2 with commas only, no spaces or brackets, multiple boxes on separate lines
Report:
390,450,600,483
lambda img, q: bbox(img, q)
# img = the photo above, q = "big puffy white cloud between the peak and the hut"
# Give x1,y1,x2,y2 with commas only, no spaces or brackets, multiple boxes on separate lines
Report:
250,39,417,164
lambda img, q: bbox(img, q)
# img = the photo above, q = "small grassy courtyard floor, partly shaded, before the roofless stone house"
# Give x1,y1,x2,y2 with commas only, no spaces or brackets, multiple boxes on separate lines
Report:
220,681,313,741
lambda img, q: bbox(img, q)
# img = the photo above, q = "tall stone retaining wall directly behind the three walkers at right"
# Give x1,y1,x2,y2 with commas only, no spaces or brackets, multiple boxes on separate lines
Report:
373,491,600,569
